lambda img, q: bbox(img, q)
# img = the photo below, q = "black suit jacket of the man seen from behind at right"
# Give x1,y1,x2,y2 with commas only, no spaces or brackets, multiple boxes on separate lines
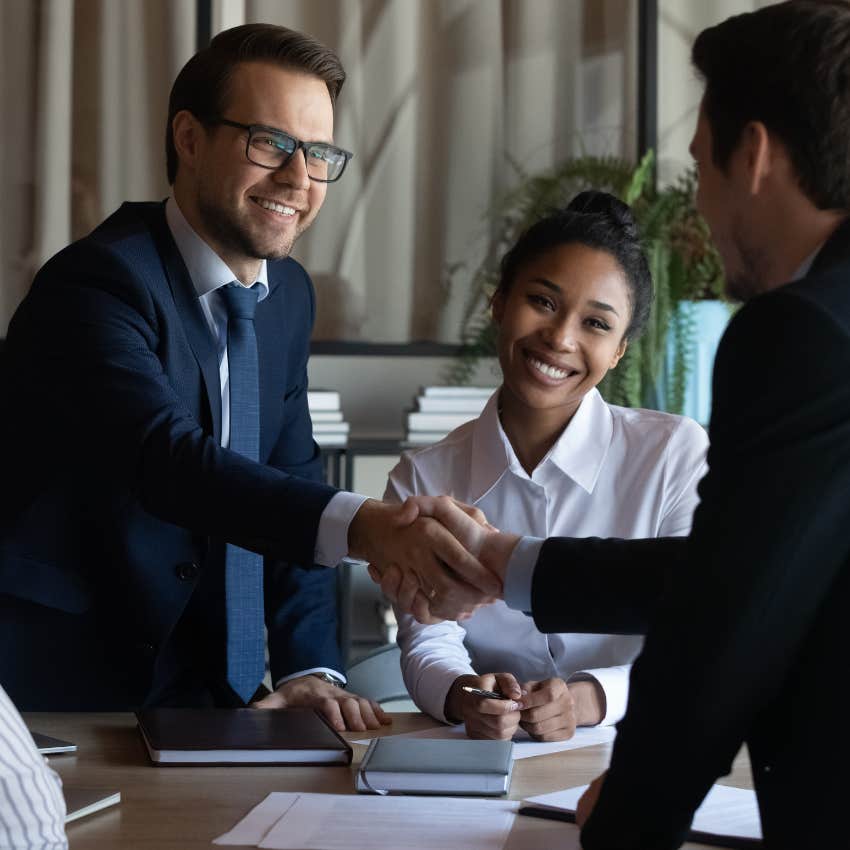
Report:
532,223,850,850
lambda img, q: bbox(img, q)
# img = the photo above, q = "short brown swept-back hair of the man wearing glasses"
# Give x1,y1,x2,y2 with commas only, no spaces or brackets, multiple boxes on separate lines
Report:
165,24,345,183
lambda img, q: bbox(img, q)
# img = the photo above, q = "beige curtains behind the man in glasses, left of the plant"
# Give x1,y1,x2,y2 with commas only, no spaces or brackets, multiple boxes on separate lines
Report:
0,0,637,342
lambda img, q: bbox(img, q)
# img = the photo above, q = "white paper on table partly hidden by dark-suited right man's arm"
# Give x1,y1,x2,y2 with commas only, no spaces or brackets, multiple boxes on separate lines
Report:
525,785,761,838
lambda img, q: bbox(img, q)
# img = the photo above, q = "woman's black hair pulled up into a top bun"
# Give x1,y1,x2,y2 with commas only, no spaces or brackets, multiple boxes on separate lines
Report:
494,190,652,339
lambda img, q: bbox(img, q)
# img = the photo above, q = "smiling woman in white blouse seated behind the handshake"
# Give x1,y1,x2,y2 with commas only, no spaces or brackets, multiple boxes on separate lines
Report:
386,192,708,740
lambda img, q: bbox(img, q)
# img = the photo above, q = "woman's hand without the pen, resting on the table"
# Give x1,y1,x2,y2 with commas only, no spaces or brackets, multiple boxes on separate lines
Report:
519,678,602,741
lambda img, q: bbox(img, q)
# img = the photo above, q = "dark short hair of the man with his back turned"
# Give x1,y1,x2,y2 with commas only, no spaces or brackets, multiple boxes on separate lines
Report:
691,0,850,210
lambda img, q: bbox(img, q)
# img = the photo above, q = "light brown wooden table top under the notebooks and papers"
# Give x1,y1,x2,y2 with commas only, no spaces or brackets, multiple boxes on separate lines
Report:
25,713,751,850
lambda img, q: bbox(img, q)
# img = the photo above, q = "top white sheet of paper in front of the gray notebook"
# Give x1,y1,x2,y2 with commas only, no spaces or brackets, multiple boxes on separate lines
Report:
259,794,517,850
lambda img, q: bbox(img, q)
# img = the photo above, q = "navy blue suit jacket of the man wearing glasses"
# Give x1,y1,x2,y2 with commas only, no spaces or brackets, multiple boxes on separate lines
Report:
0,204,340,708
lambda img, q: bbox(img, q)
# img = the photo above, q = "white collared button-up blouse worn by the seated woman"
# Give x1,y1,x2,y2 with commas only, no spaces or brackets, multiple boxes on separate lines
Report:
384,389,708,724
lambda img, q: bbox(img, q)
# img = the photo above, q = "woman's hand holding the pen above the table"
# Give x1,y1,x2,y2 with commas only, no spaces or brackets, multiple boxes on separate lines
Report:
445,673,523,741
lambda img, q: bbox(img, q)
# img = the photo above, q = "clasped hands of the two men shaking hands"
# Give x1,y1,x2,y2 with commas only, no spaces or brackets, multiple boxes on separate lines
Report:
348,496,519,623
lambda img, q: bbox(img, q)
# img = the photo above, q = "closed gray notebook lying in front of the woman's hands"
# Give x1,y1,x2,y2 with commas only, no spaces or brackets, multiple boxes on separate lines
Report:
357,737,513,797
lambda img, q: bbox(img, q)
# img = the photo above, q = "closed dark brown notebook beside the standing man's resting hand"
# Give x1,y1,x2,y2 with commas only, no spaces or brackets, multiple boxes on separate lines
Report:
136,708,351,765
